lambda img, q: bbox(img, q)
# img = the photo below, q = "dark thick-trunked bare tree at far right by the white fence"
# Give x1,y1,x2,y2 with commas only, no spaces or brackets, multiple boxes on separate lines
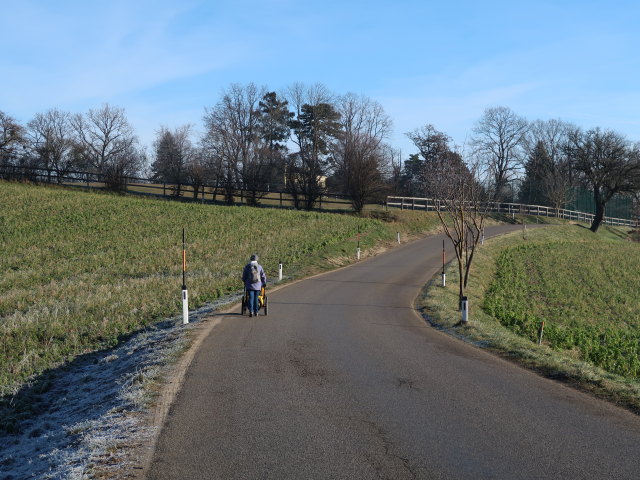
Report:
568,128,640,232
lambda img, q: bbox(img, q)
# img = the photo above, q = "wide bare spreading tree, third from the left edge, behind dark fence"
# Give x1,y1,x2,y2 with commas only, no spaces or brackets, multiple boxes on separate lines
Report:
71,104,142,186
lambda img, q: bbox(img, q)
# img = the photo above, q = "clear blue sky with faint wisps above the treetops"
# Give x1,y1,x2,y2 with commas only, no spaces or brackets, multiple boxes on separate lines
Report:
0,0,640,158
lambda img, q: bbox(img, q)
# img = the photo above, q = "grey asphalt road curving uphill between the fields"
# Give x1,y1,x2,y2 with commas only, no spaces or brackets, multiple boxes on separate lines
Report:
148,227,640,480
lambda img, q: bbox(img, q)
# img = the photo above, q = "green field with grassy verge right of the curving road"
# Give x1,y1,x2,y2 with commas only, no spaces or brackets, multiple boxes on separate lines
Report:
421,225,640,412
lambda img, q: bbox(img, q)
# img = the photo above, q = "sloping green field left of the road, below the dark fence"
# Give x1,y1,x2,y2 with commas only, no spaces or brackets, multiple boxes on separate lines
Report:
0,182,444,396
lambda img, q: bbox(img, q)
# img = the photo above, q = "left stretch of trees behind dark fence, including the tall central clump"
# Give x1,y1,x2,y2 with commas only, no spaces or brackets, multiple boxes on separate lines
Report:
0,83,399,211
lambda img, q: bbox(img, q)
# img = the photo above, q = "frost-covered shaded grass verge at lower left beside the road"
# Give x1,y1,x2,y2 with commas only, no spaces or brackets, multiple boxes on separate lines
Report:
0,299,229,480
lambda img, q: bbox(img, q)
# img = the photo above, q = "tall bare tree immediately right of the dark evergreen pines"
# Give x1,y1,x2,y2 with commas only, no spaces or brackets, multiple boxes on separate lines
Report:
332,93,391,212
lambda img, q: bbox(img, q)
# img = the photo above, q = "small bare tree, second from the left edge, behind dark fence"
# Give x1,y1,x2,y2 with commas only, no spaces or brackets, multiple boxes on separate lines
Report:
27,108,74,182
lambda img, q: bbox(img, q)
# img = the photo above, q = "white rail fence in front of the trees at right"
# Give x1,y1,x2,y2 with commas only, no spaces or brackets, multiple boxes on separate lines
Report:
387,197,638,227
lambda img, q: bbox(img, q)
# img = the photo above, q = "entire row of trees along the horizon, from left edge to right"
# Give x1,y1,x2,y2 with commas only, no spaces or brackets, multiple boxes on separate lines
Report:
0,83,640,227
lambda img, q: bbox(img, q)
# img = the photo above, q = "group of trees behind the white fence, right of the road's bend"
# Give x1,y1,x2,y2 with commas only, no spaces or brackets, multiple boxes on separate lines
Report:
396,107,640,232
